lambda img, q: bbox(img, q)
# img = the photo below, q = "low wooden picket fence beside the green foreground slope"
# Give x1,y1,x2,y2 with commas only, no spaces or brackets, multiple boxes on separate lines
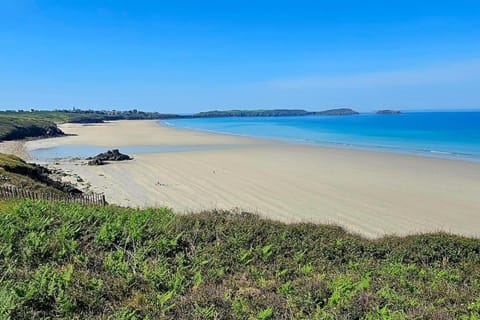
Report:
0,186,107,206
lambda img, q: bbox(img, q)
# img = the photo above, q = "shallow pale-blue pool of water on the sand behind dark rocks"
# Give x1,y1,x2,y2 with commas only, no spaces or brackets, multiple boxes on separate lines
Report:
29,145,248,161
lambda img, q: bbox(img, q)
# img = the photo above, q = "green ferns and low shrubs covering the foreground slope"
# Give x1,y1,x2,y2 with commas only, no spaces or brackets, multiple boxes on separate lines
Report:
0,201,480,319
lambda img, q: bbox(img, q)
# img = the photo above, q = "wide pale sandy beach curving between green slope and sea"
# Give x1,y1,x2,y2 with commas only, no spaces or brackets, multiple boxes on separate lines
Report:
6,121,480,238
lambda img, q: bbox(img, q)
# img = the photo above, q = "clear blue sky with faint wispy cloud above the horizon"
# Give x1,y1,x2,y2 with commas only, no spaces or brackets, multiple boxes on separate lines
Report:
0,0,480,113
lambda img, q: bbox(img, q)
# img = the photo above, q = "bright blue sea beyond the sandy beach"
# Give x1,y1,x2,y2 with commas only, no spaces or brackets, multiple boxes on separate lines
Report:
162,111,480,161
